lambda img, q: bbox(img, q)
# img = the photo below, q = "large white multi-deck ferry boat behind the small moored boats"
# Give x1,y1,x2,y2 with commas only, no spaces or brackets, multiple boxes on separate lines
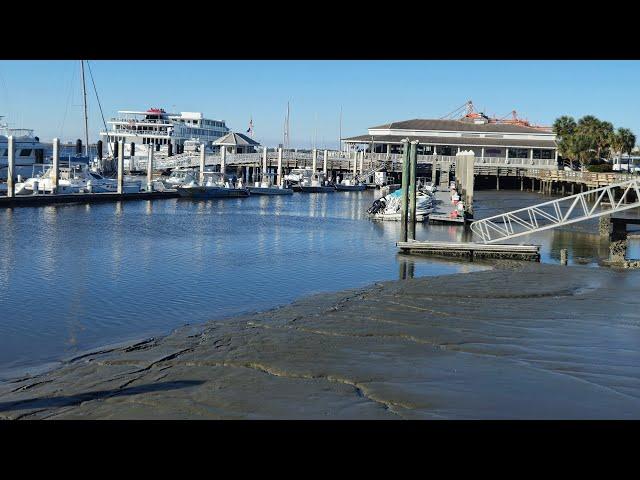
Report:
100,108,230,156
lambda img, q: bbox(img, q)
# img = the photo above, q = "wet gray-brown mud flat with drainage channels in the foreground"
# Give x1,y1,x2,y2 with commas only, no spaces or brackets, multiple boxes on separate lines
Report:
0,263,640,419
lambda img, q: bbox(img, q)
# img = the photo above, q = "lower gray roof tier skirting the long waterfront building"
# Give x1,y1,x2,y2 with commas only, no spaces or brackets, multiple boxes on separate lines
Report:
342,135,557,148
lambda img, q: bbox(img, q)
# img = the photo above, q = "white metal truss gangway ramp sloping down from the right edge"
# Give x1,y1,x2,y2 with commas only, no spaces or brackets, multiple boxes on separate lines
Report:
471,179,640,243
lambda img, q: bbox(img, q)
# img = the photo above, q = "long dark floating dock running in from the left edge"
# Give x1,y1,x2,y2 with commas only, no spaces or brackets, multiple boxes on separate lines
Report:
0,190,180,208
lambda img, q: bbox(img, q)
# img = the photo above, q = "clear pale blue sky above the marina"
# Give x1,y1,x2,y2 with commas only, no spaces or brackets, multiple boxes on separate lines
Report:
0,60,640,148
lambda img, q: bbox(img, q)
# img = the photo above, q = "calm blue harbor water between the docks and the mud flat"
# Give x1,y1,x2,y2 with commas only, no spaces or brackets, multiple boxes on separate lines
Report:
0,191,640,378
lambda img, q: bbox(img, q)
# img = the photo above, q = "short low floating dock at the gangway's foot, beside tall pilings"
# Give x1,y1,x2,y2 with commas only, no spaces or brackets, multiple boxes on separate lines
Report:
396,240,540,262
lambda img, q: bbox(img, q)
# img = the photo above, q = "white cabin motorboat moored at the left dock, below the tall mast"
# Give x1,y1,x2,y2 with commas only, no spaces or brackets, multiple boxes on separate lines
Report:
16,165,142,195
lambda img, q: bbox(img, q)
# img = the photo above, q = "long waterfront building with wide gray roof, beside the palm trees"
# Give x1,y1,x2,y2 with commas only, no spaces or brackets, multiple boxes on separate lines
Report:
342,117,558,164
